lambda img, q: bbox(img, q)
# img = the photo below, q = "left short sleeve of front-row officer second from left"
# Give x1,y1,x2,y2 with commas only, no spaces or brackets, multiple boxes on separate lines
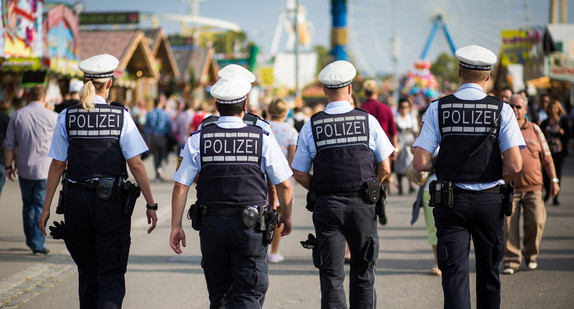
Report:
173,131,201,187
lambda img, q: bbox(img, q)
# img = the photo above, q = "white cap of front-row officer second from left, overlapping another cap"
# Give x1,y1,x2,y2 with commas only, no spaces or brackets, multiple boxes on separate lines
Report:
209,76,251,104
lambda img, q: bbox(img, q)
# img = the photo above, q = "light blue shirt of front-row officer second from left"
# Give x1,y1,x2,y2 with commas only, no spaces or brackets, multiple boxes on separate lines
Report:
173,116,293,186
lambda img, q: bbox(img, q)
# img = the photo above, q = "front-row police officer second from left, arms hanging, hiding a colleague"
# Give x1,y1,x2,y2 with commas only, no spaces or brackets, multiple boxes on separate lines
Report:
170,71,293,308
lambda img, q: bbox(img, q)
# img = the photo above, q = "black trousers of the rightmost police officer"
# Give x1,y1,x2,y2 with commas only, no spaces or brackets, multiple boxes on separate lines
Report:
433,192,504,308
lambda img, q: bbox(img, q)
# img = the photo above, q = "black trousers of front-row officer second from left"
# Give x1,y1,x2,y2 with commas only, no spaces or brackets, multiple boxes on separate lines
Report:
199,216,269,309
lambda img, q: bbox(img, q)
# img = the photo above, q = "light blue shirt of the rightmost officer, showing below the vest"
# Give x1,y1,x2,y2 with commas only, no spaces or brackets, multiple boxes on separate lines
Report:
413,83,526,191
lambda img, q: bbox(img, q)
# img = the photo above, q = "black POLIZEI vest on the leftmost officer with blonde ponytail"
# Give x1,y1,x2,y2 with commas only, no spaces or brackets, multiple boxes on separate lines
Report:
66,103,128,181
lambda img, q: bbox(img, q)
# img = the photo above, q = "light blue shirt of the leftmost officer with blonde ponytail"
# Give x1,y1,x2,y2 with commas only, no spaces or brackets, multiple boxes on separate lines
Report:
49,96,148,162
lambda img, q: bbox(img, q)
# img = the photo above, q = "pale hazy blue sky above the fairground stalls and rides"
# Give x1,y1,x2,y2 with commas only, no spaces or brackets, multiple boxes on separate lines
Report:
54,0,574,75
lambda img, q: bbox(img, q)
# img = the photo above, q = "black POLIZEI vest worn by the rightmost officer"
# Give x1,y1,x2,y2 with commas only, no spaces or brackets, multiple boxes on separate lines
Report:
436,95,504,183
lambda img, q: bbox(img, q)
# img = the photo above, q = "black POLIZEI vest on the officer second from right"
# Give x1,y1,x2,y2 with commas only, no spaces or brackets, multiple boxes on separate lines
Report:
311,108,375,193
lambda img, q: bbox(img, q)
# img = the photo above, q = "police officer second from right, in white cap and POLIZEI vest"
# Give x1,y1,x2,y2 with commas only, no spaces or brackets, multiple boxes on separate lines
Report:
292,61,394,308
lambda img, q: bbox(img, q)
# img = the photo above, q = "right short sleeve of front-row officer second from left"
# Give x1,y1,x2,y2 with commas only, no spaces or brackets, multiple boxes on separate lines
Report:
261,131,293,185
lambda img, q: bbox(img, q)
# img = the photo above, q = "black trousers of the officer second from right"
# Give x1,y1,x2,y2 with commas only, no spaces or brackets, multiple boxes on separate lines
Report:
313,195,379,308
